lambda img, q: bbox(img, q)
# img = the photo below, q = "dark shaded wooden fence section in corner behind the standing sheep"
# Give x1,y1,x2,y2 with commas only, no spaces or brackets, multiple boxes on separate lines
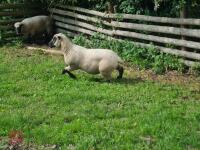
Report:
0,3,45,40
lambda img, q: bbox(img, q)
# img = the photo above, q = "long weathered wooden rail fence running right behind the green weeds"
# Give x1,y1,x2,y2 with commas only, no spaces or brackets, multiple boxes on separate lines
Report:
50,6,200,66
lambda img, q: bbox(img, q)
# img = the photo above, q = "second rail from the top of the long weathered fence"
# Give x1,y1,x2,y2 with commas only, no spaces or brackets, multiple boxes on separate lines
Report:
50,9,200,38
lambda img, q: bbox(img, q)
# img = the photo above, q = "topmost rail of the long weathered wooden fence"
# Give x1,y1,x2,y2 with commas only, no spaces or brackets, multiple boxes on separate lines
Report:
57,6,200,26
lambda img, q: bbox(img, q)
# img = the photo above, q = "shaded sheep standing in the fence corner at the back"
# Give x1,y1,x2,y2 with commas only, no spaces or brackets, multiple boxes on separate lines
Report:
14,16,53,42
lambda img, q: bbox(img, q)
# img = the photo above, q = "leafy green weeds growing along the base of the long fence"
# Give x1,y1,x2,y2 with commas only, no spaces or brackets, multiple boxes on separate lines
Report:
73,34,184,74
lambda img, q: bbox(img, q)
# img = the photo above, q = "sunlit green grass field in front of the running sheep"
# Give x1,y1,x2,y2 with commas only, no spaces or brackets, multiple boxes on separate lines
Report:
0,47,200,150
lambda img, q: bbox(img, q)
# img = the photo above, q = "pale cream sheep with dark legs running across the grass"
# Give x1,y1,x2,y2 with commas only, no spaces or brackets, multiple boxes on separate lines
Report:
49,33,124,81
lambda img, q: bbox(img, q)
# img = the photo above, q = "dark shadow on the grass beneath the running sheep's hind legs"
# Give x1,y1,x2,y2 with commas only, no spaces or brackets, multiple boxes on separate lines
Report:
89,78,144,85
